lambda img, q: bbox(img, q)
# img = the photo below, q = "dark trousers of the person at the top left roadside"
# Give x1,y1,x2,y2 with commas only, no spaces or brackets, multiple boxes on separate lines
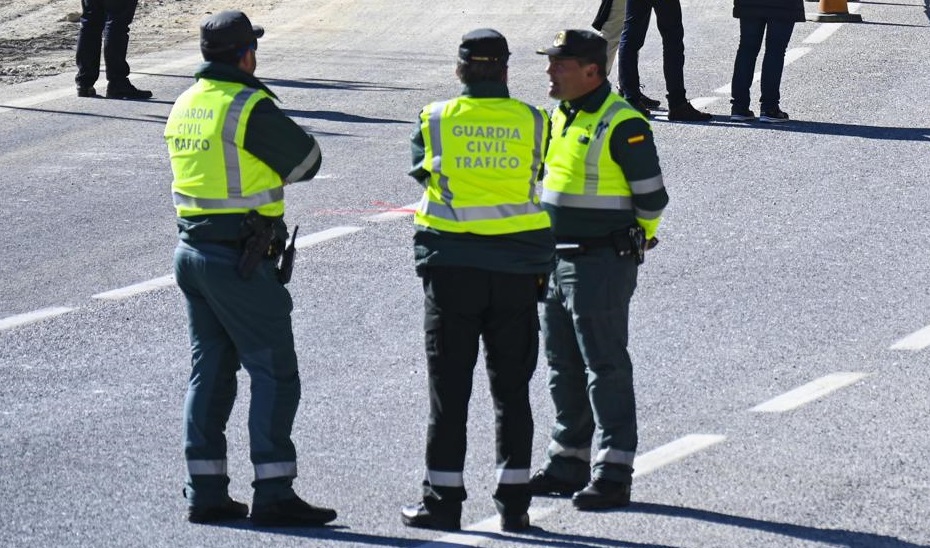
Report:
74,0,137,87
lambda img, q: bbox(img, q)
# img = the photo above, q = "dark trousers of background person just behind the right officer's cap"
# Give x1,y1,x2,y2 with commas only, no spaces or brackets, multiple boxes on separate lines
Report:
614,0,687,107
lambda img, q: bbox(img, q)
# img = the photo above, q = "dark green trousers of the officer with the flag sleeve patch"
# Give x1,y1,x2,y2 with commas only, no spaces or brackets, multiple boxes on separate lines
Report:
542,248,638,483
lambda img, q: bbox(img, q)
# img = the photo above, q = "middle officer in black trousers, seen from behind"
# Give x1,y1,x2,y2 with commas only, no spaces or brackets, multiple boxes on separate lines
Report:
402,29,554,530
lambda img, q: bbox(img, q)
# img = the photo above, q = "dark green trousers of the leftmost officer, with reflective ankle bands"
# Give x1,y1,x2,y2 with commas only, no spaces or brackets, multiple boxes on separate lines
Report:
174,242,300,506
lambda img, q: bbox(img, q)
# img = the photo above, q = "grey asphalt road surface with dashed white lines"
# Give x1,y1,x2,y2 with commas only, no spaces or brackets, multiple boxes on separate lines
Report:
0,0,930,548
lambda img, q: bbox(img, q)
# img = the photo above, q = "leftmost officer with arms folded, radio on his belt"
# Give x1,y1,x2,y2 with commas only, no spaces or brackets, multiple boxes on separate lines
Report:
165,11,336,526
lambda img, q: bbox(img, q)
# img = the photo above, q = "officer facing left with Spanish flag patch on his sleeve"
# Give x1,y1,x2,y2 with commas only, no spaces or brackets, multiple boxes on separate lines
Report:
530,30,668,510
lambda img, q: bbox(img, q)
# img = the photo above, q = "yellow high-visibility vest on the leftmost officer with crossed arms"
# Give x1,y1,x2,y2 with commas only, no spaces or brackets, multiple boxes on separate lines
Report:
165,78,284,217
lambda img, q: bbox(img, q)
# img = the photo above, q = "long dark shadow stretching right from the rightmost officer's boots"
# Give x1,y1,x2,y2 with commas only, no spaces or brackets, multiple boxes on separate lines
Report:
625,502,930,548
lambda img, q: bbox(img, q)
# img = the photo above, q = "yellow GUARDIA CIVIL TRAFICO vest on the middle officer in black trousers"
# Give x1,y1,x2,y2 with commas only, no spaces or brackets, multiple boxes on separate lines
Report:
414,97,550,235
